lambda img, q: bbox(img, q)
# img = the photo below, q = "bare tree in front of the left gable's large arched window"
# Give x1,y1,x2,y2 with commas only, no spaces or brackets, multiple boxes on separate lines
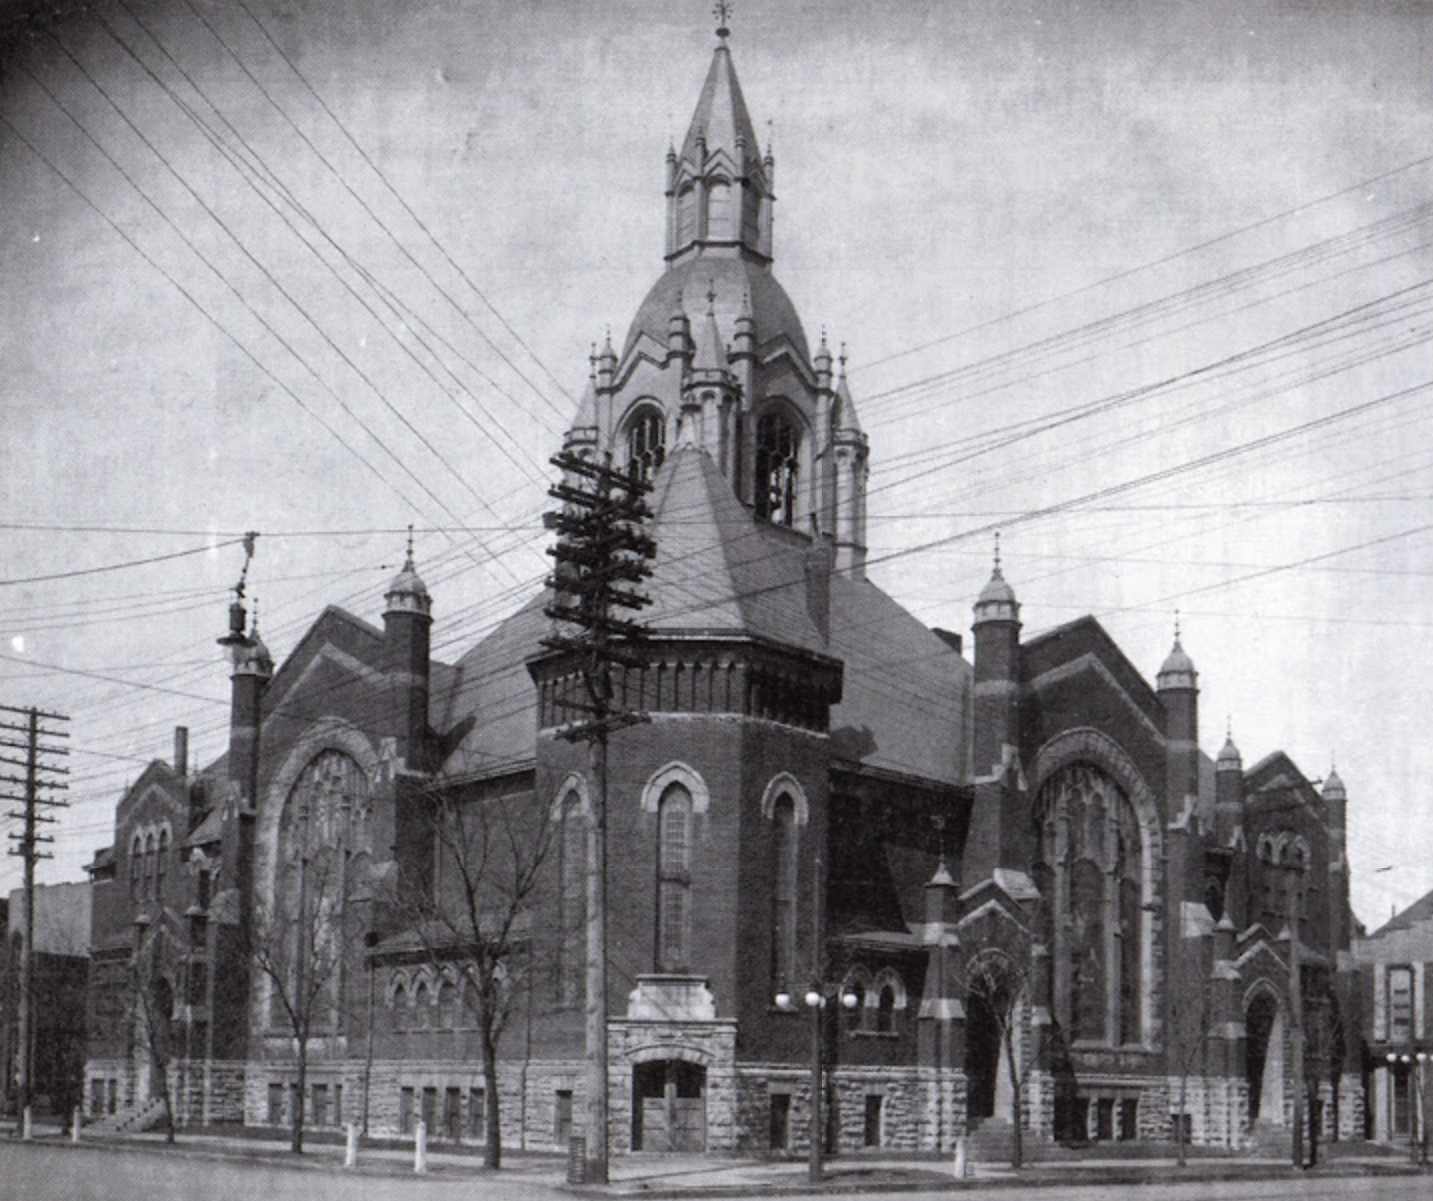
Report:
248,828,367,1154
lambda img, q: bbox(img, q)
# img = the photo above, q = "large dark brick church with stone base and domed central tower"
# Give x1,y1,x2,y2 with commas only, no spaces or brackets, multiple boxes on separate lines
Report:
86,18,1363,1152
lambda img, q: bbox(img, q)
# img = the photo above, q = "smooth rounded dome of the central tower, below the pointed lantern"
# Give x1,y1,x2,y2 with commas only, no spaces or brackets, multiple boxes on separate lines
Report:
622,254,811,363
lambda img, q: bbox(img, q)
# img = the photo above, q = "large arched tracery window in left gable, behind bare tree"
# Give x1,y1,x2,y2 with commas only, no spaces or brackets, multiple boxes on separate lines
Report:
264,750,373,1028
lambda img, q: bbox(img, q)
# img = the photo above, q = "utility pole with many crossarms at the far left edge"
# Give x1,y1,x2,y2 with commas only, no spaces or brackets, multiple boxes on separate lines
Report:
0,705,70,1138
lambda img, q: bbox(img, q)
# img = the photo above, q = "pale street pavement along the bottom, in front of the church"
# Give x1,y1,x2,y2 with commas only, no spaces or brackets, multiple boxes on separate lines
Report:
0,1128,1433,1201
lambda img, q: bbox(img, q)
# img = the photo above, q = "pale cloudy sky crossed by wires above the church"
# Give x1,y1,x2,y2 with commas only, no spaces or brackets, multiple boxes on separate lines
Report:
0,0,1433,927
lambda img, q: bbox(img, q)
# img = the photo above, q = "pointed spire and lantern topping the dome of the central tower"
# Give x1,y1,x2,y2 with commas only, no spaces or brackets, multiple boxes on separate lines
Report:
666,11,775,264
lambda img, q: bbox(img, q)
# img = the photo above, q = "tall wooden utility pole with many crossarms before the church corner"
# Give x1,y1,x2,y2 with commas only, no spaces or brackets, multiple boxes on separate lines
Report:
543,453,656,1184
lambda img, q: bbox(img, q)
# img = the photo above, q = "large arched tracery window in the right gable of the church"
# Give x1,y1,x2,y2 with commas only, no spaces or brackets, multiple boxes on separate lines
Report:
1035,762,1144,1043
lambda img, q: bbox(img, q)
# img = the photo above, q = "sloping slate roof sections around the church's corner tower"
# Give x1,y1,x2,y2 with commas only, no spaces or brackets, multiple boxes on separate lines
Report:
433,446,970,785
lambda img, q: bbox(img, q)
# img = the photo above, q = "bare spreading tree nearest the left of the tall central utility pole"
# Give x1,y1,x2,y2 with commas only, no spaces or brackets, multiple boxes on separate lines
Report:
404,787,558,1168
